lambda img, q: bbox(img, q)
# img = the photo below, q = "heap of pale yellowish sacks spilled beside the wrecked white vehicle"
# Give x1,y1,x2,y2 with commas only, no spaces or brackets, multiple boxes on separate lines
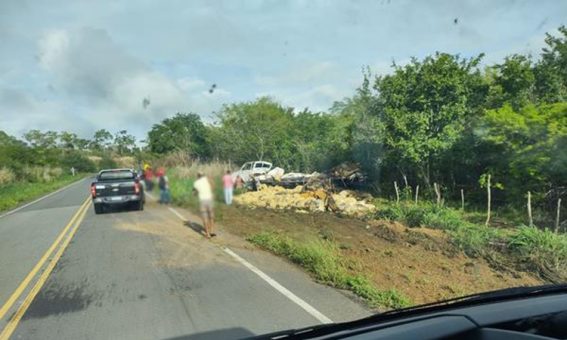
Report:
234,185,376,217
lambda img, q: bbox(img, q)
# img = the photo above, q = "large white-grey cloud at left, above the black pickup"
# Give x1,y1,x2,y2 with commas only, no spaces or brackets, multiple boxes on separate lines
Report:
20,28,231,138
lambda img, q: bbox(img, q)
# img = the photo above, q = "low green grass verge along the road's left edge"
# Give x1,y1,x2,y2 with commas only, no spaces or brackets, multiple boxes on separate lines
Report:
0,175,80,212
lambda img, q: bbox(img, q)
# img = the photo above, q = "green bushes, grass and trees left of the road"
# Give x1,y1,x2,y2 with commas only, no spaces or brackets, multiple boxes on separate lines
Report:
0,130,142,211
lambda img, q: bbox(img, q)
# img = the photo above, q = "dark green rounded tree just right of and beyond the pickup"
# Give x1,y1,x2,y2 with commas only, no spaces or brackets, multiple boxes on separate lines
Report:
148,113,208,157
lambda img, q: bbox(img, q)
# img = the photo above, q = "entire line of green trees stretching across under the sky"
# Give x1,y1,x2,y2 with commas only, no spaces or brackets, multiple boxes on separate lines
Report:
0,26,567,223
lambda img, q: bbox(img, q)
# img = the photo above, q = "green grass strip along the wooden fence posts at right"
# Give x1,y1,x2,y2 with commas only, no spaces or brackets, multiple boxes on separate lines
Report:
375,201,567,282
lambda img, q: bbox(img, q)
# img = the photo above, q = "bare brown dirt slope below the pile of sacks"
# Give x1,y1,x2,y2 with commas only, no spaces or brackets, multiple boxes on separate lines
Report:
221,207,543,304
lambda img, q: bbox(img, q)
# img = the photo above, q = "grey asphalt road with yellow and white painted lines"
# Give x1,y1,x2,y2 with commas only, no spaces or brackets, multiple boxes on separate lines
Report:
0,180,370,339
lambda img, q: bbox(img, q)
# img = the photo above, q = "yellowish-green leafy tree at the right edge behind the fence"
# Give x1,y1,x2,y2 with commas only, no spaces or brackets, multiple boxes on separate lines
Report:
482,103,567,199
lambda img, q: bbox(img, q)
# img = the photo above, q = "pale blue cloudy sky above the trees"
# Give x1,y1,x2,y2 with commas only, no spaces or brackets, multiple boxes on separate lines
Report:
0,0,567,139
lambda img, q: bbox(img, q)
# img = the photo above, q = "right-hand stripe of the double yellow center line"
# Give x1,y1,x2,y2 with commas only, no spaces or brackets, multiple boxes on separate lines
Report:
0,201,90,340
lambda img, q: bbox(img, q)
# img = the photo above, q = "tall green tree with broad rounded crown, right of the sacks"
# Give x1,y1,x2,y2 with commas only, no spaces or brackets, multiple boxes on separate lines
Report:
371,53,487,186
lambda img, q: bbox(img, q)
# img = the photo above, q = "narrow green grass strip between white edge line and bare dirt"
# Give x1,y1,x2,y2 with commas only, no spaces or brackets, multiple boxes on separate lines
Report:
248,232,411,308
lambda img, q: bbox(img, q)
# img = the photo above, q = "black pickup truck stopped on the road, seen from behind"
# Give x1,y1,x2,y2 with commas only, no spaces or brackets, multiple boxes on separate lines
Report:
91,169,145,214
